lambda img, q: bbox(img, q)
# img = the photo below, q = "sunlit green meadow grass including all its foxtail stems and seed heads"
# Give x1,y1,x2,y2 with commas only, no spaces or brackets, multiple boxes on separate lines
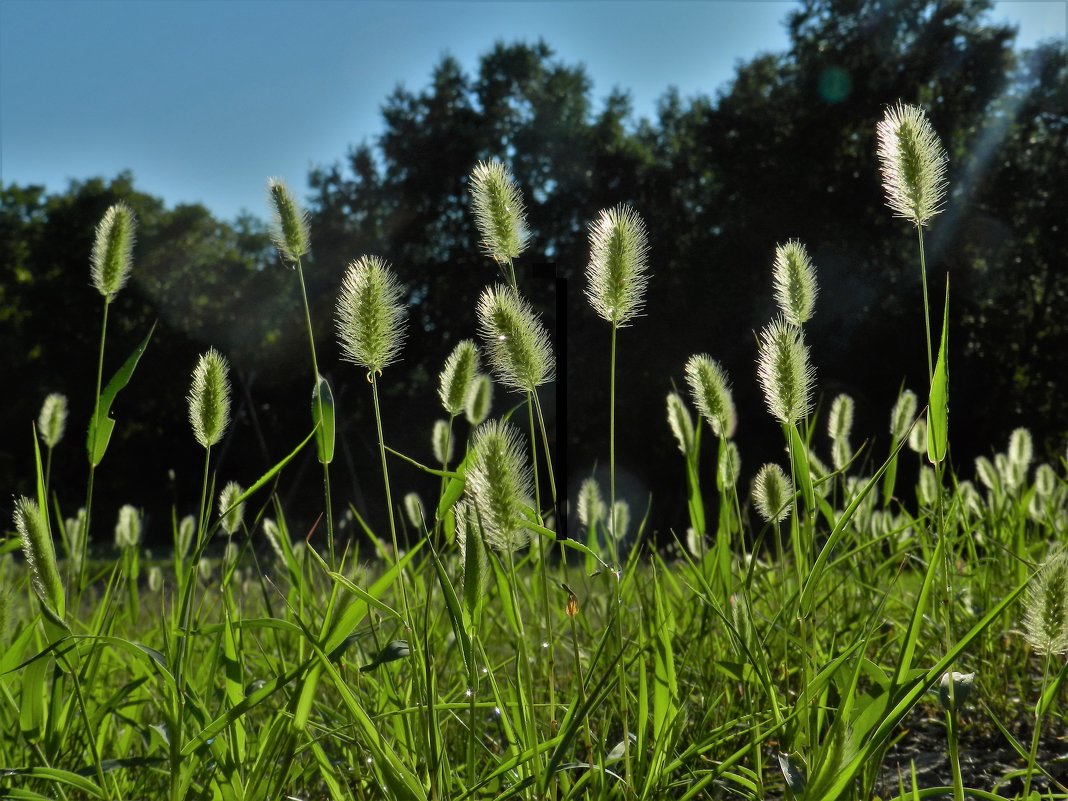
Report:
0,104,1068,801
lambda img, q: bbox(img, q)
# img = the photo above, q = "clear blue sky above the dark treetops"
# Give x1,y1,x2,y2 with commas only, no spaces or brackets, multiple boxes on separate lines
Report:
0,0,1068,218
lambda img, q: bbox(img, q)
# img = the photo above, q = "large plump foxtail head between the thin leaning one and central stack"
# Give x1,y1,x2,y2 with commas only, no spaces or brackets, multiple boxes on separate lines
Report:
337,256,408,373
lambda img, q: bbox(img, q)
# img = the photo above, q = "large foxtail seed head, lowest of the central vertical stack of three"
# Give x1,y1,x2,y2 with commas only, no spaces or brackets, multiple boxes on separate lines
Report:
467,420,534,552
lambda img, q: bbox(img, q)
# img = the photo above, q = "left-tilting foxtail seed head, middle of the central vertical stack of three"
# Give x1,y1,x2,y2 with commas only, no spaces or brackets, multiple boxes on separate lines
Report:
477,284,555,392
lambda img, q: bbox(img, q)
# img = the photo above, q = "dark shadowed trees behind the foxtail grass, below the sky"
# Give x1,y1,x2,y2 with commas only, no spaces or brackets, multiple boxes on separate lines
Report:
0,0,1068,541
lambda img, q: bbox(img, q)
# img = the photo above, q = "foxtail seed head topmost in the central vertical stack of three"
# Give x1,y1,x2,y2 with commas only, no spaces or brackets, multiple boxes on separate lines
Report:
470,159,530,264
